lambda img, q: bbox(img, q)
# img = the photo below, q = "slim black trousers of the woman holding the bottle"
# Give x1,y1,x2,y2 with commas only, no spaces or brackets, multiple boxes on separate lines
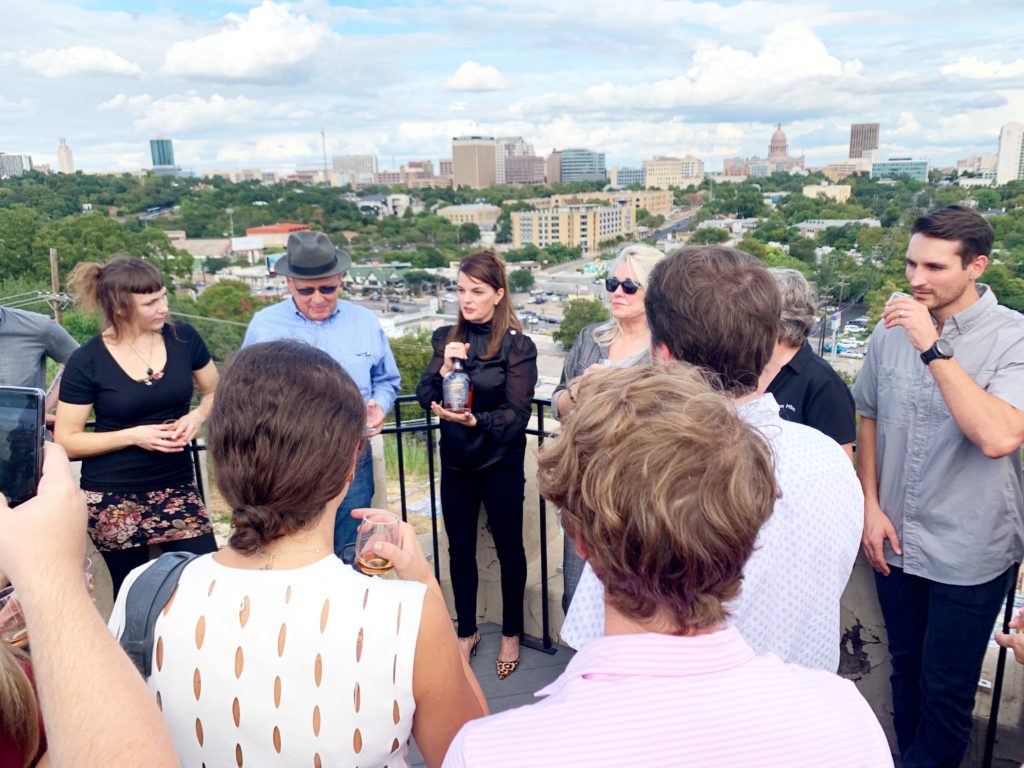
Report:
441,453,526,637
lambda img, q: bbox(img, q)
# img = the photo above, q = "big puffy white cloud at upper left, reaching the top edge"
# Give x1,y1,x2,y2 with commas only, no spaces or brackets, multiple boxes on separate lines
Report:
163,0,338,81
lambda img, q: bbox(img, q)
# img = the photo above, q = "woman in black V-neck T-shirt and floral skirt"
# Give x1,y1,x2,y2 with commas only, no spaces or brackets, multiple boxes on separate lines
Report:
54,256,217,595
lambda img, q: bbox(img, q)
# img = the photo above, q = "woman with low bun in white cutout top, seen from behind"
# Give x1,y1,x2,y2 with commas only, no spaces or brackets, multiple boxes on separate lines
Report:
111,340,485,768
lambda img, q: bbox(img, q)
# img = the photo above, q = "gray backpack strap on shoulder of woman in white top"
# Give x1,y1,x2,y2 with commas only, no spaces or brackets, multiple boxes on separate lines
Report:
119,552,198,679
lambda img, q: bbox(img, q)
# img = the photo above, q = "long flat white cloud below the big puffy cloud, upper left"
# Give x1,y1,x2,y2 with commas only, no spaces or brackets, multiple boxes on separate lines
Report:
96,91,313,133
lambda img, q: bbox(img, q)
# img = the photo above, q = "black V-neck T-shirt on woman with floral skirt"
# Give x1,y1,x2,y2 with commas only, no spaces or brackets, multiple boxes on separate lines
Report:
60,323,210,493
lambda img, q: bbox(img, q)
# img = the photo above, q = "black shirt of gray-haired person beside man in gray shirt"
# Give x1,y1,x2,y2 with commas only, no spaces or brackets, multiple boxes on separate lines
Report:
768,341,857,445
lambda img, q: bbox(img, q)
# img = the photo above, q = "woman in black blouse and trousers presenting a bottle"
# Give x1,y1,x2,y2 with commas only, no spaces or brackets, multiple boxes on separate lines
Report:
416,252,537,679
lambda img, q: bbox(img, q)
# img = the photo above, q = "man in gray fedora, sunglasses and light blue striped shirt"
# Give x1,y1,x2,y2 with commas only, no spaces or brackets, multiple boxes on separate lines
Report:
242,230,401,557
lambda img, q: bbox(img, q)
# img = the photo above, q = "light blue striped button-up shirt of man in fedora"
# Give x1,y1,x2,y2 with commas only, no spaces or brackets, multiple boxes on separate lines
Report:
242,298,401,414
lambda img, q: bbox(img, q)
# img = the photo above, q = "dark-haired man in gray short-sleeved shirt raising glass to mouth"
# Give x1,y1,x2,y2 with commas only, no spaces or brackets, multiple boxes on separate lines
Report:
854,206,1024,768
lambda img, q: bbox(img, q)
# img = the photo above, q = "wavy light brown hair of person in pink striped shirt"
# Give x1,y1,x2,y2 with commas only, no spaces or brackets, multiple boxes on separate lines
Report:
538,362,777,635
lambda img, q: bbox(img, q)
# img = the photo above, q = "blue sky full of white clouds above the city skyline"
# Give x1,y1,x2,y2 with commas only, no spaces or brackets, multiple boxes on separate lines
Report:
0,0,1024,171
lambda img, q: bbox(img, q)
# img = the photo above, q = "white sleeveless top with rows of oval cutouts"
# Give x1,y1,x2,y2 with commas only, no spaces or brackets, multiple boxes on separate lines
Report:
110,555,426,768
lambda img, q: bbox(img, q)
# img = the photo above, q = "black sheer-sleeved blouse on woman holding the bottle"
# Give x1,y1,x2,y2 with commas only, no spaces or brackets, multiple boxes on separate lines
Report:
416,323,537,469
